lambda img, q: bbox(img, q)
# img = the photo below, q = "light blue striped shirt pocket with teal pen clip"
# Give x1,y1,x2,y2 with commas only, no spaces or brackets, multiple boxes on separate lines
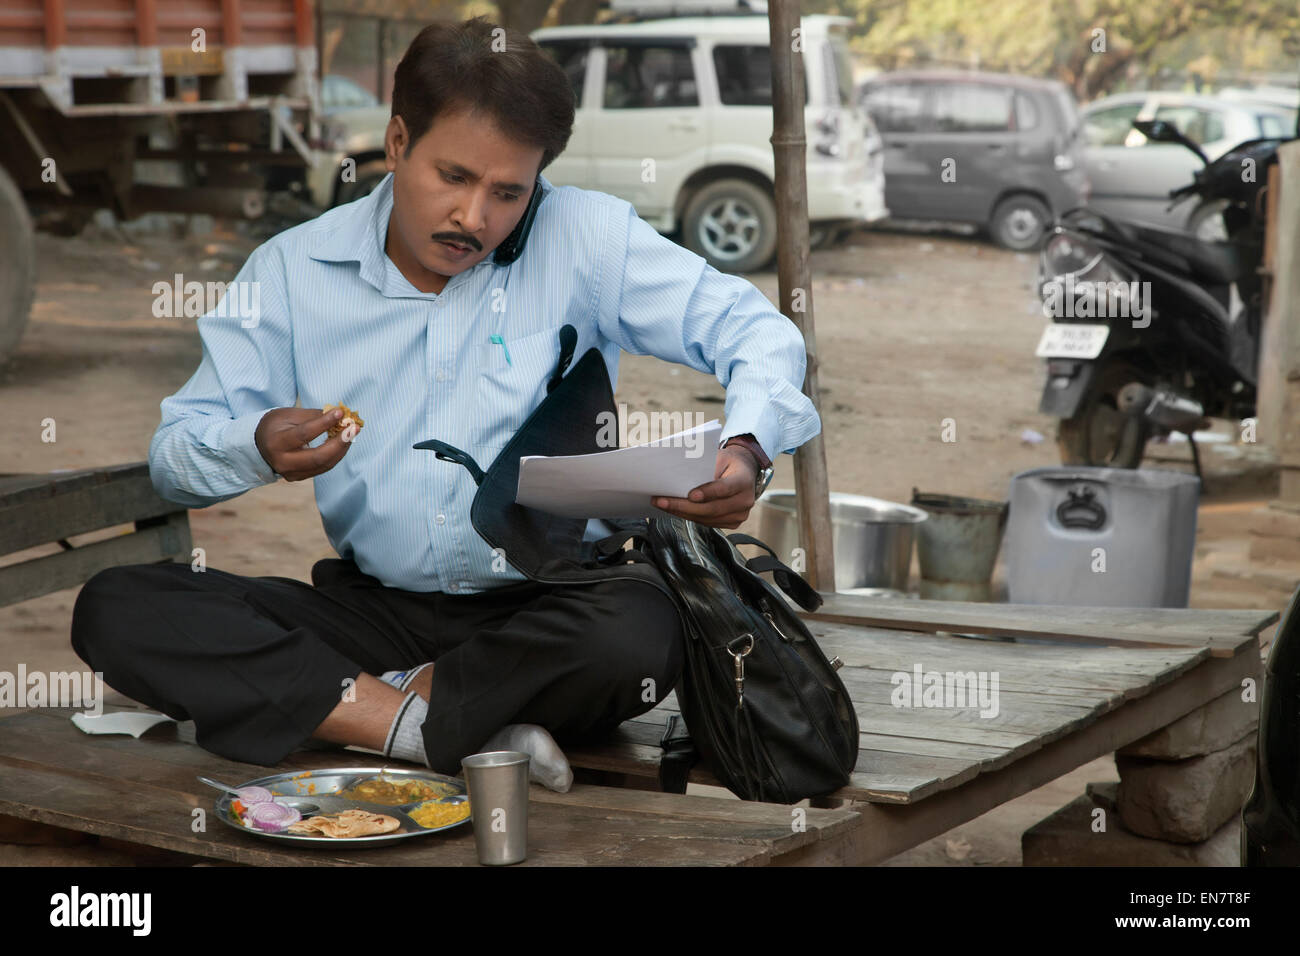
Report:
473,325,562,447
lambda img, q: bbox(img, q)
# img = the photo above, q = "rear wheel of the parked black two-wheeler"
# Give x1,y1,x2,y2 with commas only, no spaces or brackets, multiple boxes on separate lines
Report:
1057,362,1151,468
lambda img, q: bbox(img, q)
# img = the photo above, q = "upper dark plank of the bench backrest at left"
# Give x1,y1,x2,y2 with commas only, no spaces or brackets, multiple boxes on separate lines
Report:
0,463,185,554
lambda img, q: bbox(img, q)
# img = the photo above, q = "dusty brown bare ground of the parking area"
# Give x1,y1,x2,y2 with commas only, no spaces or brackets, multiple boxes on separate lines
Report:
0,214,1295,865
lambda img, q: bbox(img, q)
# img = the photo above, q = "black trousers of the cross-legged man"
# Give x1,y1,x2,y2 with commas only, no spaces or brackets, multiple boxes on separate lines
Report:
72,558,684,774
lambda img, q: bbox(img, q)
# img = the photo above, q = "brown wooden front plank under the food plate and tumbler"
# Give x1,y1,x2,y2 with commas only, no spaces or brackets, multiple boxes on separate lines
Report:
0,709,857,865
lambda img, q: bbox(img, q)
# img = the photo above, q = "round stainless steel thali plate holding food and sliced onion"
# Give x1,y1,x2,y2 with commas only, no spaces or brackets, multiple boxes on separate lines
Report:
216,767,472,848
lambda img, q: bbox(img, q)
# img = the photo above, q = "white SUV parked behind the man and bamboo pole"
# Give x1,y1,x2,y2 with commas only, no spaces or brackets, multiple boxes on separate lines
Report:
532,14,888,272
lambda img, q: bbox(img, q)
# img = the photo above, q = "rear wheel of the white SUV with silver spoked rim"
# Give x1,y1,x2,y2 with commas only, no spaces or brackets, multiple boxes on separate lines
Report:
681,179,776,272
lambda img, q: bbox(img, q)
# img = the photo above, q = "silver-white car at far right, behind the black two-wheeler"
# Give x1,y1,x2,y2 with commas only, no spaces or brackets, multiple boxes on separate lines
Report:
1083,91,1296,239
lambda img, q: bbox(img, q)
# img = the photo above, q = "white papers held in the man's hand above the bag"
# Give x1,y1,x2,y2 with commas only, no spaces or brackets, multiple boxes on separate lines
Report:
515,419,723,518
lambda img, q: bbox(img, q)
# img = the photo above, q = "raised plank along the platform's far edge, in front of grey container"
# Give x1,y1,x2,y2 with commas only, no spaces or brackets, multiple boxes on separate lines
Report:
800,593,1278,657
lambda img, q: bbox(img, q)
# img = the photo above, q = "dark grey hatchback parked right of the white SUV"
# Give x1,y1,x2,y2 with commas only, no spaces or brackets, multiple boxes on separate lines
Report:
859,70,1088,250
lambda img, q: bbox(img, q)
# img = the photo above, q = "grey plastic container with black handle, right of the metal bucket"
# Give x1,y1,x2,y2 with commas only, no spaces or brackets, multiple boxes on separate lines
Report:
1004,466,1200,607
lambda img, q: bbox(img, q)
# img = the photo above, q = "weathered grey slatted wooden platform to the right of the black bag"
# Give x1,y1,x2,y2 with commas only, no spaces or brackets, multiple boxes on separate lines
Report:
568,594,1278,864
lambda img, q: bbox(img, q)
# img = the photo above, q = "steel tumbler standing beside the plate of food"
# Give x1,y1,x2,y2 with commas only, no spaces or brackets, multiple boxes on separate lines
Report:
460,750,529,866
